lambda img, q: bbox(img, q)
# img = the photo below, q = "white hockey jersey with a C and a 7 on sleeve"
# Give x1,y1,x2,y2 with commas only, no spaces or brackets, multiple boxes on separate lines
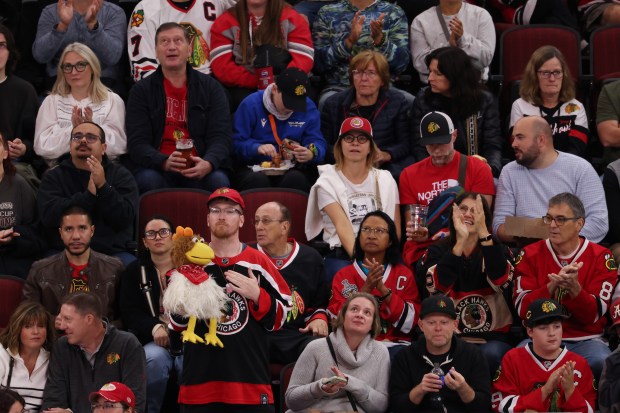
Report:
127,0,236,82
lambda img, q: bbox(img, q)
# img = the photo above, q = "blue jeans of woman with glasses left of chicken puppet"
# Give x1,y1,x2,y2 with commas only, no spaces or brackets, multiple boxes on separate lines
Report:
144,341,183,413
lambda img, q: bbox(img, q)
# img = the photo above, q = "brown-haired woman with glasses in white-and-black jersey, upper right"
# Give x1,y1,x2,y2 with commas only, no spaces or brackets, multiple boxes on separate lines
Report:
510,46,590,157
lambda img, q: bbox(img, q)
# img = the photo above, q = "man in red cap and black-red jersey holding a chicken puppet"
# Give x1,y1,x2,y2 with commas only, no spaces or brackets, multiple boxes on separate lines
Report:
170,188,291,413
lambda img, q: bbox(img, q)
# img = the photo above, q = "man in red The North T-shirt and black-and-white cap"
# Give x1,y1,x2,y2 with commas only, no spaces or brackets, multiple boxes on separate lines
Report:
399,112,495,266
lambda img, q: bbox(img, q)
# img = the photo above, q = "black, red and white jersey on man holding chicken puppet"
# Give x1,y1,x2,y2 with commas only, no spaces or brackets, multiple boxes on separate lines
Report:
171,246,291,406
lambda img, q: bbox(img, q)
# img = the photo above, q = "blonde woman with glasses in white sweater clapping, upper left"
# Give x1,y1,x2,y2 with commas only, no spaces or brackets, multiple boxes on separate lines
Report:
34,43,127,166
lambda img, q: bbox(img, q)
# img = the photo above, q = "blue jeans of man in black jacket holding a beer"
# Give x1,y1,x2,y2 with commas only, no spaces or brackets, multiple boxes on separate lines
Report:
134,169,230,194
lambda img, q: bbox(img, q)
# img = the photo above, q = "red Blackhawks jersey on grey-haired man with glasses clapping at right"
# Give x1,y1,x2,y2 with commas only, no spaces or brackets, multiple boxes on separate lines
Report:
514,237,618,341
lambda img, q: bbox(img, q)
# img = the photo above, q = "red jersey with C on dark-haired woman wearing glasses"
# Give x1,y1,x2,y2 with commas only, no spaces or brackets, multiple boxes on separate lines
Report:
327,261,420,343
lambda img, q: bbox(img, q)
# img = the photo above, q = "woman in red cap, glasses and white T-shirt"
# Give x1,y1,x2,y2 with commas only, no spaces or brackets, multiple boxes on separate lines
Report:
306,117,400,280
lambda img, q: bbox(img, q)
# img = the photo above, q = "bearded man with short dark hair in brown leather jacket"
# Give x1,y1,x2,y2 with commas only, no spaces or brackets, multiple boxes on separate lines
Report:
24,206,123,322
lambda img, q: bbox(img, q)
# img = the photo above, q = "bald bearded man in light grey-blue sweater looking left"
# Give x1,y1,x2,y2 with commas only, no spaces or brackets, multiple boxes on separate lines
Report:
493,116,608,243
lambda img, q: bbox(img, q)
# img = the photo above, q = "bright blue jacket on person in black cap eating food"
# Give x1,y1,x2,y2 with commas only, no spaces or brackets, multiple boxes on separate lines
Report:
233,90,327,165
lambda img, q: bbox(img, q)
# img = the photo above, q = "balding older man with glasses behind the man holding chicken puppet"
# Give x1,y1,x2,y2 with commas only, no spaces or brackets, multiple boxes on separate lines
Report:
254,202,330,364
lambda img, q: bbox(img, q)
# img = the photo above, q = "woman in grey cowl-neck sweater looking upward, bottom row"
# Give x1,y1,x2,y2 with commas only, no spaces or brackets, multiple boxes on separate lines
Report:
286,293,390,413
